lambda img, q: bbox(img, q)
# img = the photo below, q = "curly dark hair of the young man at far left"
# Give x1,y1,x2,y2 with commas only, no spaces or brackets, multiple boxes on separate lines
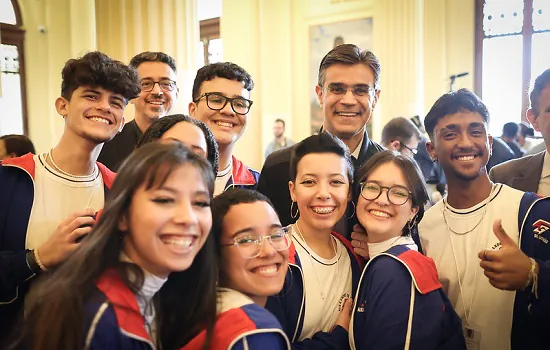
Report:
61,51,140,102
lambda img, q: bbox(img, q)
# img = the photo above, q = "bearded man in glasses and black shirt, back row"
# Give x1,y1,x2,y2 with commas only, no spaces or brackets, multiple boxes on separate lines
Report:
98,51,179,171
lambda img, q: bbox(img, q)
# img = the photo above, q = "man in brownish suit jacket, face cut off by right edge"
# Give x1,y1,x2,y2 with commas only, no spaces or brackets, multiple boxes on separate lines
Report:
489,69,550,196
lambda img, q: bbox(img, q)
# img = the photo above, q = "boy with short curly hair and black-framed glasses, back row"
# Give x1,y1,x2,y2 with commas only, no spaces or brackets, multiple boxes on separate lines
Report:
189,62,260,196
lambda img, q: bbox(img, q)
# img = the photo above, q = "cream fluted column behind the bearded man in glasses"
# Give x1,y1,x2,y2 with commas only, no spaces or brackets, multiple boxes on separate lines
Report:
95,0,199,122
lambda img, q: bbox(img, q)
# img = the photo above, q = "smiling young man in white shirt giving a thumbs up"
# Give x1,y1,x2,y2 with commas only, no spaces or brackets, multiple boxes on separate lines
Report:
419,89,550,350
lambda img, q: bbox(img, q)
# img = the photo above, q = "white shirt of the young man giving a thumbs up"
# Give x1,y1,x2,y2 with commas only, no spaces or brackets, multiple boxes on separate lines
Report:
419,184,523,350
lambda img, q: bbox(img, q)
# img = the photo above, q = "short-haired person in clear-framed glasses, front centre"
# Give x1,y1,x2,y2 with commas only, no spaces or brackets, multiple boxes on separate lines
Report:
184,189,290,350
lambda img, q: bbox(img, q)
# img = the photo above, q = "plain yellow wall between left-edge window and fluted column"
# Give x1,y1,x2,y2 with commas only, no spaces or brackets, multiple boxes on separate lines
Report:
19,0,96,152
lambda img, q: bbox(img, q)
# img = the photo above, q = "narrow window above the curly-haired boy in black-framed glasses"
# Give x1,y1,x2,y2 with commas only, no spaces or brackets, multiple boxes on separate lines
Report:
197,0,223,66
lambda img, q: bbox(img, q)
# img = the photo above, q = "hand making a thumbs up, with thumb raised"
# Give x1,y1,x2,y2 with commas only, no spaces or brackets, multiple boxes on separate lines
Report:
478,220,531,290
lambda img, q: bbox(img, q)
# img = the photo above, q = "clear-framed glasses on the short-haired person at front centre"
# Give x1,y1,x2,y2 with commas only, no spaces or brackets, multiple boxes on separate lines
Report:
222,226,291,259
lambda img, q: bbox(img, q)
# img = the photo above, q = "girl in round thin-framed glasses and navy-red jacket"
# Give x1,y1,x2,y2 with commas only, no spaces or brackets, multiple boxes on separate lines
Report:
349,151,466,350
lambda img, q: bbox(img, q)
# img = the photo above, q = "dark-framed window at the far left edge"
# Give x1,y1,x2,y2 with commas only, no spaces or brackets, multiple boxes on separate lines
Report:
0,0,28,135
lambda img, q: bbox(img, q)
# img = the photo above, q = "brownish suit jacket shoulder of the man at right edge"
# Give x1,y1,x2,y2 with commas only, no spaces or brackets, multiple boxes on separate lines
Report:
489,151,546,193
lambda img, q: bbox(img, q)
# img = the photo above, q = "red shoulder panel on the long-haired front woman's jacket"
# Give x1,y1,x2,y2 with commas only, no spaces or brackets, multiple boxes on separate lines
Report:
96,269,153,346
